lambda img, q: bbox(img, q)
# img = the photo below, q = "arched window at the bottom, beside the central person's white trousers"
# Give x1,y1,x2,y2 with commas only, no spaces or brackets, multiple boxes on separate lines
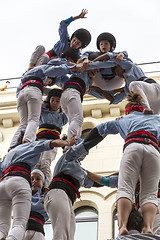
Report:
74,206,98,240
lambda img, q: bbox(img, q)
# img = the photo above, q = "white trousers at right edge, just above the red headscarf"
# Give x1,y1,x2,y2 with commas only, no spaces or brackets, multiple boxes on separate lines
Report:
129,81,160,114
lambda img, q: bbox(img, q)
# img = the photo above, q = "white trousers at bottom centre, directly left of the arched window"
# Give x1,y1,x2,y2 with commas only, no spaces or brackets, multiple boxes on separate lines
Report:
44,189,75,240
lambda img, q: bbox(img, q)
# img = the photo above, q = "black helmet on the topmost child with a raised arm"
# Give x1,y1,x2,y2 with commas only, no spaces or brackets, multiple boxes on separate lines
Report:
71,28,91,48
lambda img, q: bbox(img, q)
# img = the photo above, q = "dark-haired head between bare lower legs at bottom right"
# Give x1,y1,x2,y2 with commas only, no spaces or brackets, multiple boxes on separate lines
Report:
127,205,144,233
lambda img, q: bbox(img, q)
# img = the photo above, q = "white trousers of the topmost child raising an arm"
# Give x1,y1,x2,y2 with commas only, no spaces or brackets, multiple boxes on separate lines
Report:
30,45,49,66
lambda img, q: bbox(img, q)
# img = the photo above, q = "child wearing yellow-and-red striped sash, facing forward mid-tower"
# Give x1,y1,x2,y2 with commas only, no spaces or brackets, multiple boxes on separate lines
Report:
36,89,68,188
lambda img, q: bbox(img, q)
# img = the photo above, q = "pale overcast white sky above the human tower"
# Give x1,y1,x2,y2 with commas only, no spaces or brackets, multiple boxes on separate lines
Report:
0,0,160,87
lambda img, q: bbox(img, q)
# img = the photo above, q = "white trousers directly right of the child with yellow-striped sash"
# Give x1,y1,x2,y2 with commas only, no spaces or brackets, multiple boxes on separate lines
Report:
60,88,83,138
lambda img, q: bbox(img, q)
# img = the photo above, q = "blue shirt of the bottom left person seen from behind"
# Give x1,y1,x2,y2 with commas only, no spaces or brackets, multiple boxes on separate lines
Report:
1,140,51,171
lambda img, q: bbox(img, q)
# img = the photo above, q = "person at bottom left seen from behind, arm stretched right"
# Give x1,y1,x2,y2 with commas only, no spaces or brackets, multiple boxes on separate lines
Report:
0,138,76,240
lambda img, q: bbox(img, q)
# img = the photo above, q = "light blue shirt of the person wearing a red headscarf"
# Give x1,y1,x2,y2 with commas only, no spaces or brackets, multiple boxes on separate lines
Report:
96,111,160,139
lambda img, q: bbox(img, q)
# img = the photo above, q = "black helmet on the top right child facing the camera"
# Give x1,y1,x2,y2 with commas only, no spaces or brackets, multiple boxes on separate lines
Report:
97,32,116,52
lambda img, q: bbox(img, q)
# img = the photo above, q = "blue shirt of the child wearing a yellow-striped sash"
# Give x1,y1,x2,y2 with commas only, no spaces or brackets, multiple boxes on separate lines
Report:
39,108,68,130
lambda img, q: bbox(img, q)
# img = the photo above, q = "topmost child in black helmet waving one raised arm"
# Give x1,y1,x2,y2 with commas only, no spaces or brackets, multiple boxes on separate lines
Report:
28,9,91,70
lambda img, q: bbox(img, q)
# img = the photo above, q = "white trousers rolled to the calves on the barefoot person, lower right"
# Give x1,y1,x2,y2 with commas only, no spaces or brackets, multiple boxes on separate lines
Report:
117,143,160,206
